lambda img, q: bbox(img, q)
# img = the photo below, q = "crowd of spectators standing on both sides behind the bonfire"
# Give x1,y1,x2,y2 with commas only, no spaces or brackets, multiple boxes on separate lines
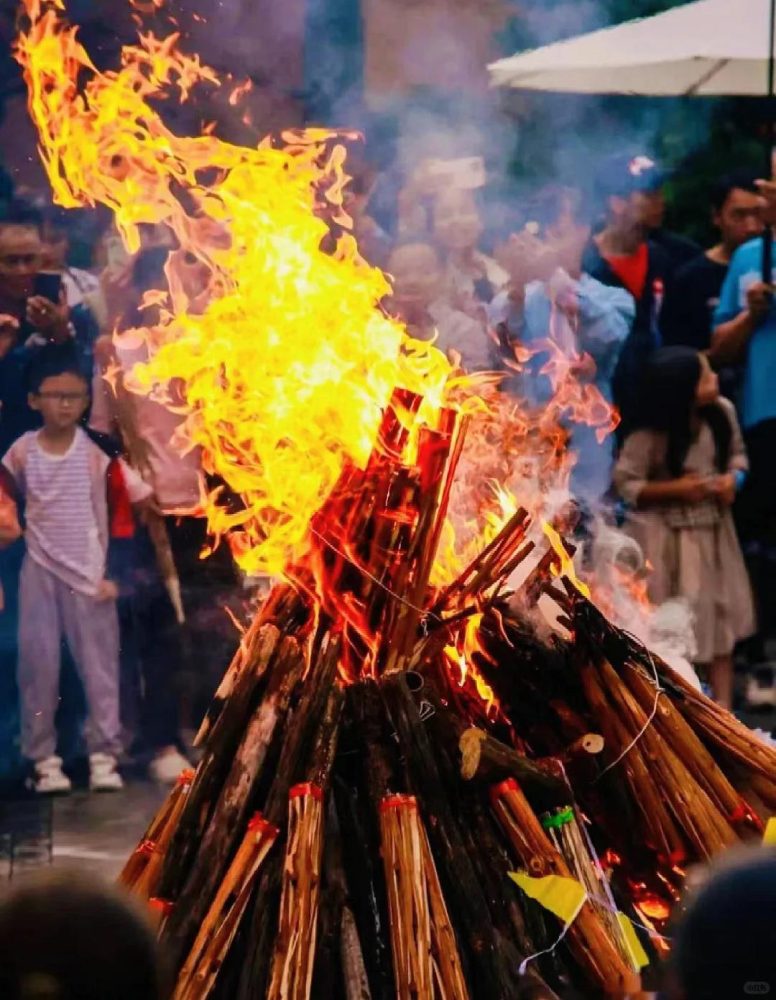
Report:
0,146,776,792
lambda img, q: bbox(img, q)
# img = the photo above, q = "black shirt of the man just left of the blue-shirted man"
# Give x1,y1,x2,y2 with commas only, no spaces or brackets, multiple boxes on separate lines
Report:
663,253,728,351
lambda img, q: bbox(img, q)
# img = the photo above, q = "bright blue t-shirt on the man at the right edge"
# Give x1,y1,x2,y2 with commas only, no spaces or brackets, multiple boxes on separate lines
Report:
714,237,776,427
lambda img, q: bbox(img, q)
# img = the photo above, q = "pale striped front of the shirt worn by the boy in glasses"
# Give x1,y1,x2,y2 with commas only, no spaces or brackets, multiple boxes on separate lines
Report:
12,427,106,595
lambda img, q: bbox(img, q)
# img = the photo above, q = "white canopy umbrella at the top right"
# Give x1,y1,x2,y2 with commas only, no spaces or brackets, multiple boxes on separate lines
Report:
489,0,772,97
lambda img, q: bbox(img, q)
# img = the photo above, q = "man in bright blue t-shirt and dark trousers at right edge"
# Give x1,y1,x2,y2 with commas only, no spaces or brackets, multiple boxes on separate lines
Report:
709,223,776,658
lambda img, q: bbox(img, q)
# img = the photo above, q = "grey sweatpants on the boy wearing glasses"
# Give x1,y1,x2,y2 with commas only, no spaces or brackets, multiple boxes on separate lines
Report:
18,556,121,761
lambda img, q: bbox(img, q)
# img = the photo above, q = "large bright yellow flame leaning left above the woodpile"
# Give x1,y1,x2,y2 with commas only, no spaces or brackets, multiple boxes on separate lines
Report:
16,0,451,573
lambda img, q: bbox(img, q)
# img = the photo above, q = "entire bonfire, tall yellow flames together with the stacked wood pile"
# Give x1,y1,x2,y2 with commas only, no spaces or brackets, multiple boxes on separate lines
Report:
16,0,776,1000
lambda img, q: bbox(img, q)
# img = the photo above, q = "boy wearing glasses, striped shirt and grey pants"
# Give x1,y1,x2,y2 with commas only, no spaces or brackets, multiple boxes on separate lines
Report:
3,347,150,793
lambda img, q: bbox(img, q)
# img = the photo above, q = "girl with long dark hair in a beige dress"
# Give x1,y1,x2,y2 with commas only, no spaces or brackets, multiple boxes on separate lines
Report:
615,347,754,708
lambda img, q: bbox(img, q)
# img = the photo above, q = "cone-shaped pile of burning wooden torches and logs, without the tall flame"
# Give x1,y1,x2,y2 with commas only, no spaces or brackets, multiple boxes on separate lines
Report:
121,390,776,1000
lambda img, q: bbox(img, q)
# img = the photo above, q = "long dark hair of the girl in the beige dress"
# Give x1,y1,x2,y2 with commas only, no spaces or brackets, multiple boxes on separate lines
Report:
639,347,733,479
